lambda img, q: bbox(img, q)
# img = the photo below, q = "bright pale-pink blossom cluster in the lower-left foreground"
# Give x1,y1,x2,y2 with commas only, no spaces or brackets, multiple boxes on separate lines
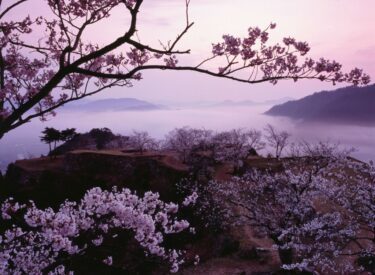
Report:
0,188,196,274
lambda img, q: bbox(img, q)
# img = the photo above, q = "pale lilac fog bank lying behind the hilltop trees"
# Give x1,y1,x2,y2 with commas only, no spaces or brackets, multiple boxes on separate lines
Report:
0,105,375,171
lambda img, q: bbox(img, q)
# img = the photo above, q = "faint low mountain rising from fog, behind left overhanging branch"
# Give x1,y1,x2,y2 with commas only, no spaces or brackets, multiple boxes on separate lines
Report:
64,98,165,112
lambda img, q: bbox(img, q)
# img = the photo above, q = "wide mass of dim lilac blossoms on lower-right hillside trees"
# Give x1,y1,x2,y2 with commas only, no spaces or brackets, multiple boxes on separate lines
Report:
209,147,375,274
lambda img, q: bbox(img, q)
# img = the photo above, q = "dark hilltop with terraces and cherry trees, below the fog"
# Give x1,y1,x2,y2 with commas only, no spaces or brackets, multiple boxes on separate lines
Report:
0,128,375,275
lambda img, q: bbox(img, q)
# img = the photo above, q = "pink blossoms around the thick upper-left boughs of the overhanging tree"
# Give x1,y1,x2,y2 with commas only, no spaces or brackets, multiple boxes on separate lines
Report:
0,0,171,130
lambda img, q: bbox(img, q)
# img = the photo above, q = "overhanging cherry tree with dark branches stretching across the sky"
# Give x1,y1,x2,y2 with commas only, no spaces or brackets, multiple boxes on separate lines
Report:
0,0,370,138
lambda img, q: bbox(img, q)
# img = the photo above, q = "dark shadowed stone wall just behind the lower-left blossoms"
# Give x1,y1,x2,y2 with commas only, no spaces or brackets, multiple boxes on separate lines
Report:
0,151,188,207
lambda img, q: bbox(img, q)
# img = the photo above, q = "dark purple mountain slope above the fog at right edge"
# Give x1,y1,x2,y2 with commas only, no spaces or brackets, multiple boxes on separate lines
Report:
265,84,375,124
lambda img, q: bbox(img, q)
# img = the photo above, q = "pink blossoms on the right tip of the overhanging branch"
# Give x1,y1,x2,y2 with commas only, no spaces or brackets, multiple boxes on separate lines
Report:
210,23,370,85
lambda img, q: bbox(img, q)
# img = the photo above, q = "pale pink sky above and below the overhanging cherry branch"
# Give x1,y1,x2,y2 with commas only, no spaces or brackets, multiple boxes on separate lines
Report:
8,0,375,102
